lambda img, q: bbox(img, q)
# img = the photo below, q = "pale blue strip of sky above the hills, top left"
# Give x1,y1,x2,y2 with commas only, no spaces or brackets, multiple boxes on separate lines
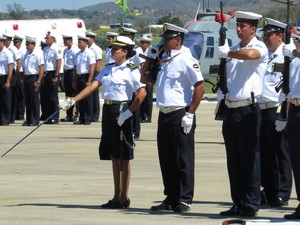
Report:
0,0,116,12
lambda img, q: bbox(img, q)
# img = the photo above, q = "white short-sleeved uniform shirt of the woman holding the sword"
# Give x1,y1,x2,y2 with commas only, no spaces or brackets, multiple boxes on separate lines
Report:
95,60,145,101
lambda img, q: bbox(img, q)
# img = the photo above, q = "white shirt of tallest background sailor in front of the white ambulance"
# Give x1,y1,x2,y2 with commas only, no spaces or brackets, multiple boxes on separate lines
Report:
44,44,62,71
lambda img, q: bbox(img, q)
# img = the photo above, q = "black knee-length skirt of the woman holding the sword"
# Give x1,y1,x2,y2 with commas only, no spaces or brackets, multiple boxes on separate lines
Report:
99,104,134,160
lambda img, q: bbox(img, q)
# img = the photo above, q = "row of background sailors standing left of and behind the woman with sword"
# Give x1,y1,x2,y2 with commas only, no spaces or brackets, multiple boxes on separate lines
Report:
0,28,152,126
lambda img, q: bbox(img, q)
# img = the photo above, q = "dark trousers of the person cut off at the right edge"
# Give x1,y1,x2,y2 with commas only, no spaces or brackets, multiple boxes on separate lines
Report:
287,104,300,201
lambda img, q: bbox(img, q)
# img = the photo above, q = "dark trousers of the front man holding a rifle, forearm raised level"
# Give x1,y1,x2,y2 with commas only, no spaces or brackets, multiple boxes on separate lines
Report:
222,104,261,211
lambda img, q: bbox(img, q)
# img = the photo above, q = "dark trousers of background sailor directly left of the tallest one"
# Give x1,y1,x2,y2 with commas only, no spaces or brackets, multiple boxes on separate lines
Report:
24,74,40,124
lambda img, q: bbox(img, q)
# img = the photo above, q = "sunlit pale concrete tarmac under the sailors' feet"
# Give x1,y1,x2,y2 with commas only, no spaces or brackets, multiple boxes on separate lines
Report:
0,96,300,225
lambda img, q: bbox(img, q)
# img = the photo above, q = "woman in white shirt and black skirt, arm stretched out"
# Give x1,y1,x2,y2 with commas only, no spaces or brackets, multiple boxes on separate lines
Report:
61,36,146,208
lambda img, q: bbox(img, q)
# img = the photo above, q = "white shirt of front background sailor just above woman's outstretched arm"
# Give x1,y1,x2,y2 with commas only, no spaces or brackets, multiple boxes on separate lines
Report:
75,48,96,74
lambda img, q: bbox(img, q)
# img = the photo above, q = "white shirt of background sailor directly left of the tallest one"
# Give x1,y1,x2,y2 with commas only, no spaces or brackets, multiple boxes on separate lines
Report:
22,48,44,76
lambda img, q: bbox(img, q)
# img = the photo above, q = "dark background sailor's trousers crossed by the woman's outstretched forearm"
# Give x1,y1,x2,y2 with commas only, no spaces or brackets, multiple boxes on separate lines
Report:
76,73,93,123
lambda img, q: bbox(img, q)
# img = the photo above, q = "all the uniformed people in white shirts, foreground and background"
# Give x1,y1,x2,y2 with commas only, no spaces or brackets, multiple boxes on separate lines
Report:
0,11,300,219
